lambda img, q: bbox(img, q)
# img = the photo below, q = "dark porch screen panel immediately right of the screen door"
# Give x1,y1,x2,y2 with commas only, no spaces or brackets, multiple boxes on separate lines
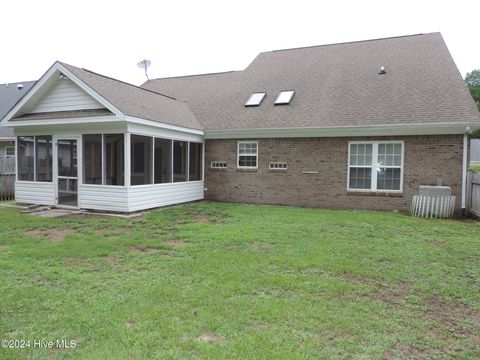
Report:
83,134,102,185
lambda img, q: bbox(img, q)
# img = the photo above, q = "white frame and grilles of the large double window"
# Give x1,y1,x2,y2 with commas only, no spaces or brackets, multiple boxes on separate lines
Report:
347,140,405,193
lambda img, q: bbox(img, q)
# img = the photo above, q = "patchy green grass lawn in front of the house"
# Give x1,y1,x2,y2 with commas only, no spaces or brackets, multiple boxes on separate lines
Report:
0,202,480,359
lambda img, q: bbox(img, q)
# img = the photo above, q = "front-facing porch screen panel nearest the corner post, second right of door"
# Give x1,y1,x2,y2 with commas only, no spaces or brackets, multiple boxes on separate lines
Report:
104,134,125,186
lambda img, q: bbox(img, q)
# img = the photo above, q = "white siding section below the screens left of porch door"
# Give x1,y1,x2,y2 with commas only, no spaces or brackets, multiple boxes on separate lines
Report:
15,181,55,205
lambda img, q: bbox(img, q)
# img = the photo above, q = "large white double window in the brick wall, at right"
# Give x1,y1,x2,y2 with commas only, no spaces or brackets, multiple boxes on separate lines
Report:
348,141,403,191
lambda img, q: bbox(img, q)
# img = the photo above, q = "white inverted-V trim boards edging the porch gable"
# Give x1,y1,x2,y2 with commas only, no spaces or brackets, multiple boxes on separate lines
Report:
3,62,124,126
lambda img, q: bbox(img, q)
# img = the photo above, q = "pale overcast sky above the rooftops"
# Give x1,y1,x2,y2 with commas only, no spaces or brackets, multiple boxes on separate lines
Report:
0,0,480,85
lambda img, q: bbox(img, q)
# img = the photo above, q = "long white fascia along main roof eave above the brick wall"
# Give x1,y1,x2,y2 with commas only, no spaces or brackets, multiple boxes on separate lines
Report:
205,123,480,139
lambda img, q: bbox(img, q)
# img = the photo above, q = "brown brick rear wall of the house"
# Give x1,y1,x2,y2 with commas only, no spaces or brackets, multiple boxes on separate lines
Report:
205,135,463,210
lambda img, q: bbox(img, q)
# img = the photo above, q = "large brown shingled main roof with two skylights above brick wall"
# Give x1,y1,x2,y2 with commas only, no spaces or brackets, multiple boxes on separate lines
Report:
142,33,480,130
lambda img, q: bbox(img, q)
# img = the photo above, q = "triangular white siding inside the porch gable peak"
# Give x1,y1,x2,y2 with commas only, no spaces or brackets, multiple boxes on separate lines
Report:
29,79,104,113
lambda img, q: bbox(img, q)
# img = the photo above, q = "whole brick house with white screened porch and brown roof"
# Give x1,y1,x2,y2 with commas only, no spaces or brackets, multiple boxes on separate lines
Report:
5,33,480,212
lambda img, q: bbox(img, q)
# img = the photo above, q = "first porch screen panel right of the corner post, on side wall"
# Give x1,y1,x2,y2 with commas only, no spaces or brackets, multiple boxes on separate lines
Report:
130,135,153,185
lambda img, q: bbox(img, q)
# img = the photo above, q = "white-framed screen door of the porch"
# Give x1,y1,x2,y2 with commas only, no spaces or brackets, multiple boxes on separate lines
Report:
57,139,78,206
